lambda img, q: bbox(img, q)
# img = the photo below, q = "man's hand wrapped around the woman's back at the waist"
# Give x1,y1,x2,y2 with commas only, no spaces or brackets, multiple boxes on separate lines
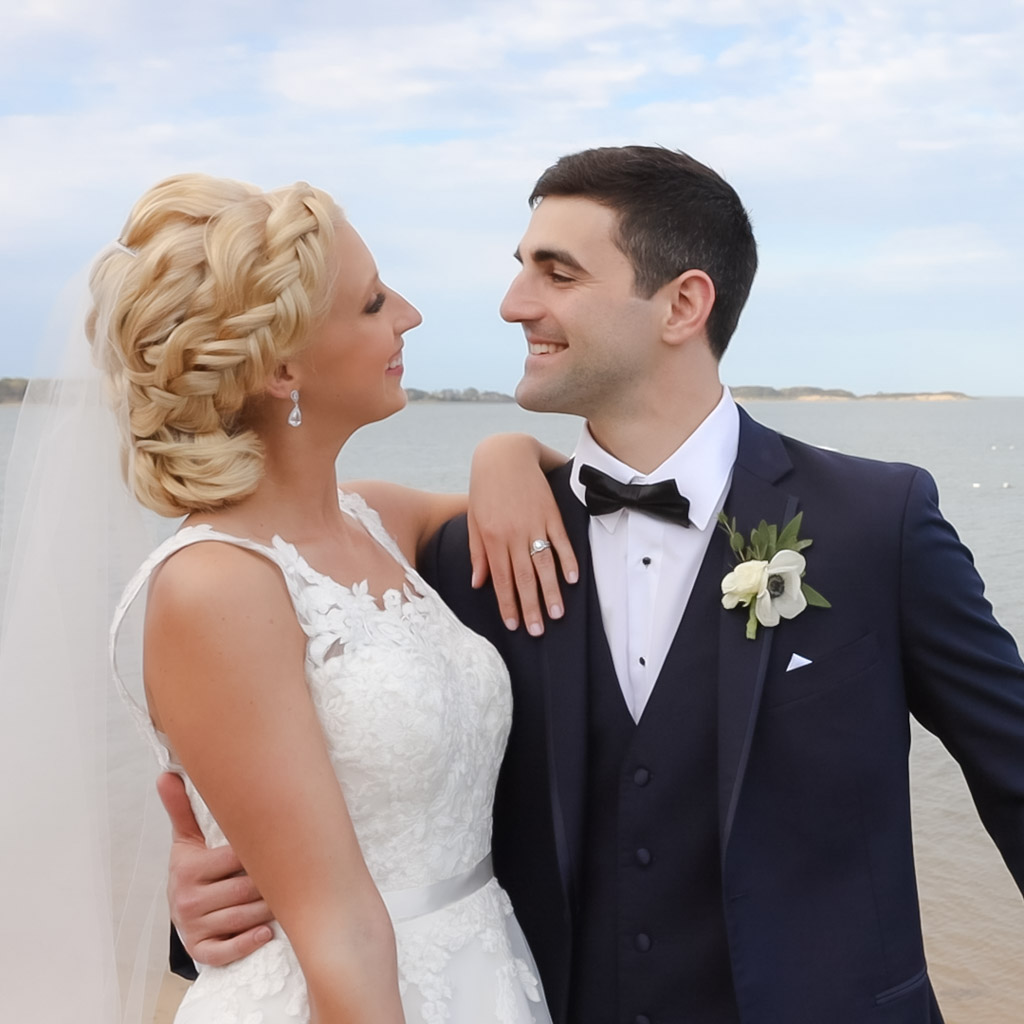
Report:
157,772,273,967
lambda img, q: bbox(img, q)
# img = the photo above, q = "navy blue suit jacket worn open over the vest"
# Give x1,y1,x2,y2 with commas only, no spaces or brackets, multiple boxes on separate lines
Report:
417,413,1024,1024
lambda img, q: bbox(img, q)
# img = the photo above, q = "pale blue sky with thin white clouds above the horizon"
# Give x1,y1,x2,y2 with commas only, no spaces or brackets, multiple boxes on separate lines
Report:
0,0,1024,395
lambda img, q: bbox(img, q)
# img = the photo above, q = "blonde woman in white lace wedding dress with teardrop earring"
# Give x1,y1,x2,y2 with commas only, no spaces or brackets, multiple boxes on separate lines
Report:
0,175,571,1024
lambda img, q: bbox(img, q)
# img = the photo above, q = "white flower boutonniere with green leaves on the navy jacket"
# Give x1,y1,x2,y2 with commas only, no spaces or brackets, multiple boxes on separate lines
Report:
718,512,831,640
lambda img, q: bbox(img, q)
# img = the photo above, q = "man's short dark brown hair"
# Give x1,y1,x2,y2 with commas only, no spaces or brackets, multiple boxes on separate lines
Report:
529,145,758,358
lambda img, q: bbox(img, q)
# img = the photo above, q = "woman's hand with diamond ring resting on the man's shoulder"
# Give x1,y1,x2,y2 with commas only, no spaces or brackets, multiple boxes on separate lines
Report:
467,434,579,636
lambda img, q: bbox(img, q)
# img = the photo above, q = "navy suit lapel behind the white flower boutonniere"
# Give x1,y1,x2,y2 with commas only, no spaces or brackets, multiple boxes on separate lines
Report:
712,410,797,857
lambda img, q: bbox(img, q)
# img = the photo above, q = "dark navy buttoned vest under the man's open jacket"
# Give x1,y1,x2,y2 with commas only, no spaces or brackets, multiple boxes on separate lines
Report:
569,531,739,1024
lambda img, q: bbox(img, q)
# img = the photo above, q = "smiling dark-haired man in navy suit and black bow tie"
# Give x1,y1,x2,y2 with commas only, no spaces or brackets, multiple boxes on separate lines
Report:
163,146,1024,1024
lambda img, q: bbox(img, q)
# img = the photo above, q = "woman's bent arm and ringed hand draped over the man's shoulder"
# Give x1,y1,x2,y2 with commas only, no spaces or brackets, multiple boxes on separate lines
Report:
343,434,579,635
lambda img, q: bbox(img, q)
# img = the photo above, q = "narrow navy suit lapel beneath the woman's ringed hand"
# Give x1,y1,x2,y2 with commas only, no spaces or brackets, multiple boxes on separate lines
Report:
540,463,593,907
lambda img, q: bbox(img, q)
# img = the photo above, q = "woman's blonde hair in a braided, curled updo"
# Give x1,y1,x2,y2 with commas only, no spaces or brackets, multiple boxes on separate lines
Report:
86,174,341,516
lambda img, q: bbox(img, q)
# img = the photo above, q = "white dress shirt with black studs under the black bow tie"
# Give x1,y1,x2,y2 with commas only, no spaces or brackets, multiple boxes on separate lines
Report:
569,388,739,722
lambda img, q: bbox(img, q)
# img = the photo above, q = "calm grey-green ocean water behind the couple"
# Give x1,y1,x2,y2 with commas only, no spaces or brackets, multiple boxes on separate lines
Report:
0,398,1024,1024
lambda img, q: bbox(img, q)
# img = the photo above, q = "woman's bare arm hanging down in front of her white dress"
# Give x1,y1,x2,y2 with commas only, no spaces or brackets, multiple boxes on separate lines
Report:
145,543,402,1024
